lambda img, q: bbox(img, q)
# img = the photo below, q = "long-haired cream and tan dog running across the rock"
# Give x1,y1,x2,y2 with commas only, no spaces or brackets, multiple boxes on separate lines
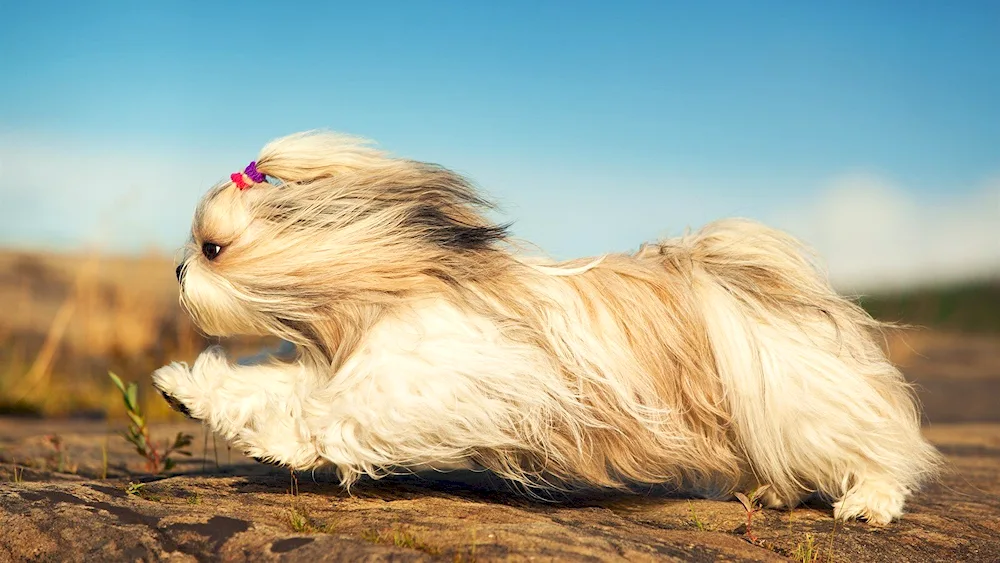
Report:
154,133,938,523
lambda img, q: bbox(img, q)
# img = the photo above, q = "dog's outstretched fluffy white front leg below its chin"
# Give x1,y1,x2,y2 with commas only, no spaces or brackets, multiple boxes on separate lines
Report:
153,346,320,469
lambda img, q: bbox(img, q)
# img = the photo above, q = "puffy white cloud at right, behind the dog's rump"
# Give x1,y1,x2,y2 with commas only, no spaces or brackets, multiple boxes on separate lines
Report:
772,175,1000,291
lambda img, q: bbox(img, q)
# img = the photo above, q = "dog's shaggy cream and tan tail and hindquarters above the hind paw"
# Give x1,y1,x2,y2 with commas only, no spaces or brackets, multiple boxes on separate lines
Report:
659,220,938,502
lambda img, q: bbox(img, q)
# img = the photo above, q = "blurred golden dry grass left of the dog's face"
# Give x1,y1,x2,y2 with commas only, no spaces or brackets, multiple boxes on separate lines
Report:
0,251,272,420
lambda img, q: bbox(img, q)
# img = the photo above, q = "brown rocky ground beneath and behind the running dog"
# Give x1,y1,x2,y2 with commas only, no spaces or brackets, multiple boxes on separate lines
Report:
0,332,1000,562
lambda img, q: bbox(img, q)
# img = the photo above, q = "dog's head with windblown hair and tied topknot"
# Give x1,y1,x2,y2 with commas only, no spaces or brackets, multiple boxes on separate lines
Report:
177,133,506,359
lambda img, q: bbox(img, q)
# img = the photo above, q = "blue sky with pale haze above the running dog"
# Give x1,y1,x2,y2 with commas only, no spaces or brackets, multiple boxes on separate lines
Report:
0,0,1000,285
